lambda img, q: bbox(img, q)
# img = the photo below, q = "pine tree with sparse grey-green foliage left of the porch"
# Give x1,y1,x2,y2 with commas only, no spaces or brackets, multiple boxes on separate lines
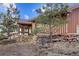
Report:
0,4,20,36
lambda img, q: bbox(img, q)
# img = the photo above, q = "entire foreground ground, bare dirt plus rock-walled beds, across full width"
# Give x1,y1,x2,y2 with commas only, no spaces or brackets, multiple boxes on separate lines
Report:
0,35,79,56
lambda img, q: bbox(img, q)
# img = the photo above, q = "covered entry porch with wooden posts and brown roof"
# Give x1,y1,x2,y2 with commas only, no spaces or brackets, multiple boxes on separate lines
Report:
17,21,36,35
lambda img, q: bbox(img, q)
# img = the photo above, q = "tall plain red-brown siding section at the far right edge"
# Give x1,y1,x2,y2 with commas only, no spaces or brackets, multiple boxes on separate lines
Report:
67,8,79,33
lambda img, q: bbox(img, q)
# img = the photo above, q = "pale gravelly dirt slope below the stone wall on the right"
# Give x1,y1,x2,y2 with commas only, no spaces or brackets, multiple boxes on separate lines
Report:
40,42,79,56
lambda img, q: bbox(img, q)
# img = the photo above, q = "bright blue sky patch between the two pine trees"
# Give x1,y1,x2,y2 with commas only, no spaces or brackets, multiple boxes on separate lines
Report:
16,3,42,19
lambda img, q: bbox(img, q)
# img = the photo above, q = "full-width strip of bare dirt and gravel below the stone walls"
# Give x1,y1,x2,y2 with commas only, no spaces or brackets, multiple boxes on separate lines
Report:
0,42,79,56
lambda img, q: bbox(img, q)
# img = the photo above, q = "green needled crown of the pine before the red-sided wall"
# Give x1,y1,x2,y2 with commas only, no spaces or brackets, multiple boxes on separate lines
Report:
36,3,68,26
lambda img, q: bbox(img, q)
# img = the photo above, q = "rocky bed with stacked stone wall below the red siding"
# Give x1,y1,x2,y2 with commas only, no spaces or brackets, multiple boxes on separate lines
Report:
37,35,79,56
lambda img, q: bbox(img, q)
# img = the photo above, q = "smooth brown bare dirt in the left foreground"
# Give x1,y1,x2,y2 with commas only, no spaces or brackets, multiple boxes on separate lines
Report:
0,43,37,56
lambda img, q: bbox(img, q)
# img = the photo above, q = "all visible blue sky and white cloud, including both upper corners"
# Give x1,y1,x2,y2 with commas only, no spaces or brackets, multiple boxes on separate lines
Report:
0,3,79,20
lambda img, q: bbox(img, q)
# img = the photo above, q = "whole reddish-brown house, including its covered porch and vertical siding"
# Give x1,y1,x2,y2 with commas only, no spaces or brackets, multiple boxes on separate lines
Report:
18,5,79,34
